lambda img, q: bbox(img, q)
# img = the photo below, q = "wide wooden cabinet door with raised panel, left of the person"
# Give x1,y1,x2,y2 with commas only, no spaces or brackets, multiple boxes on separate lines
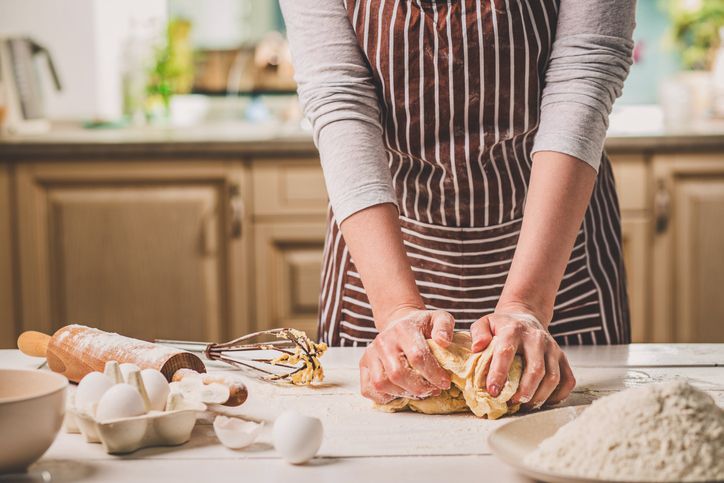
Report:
18,162,248,340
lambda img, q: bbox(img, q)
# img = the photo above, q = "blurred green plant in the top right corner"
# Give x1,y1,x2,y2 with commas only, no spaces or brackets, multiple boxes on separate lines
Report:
661,0,724,70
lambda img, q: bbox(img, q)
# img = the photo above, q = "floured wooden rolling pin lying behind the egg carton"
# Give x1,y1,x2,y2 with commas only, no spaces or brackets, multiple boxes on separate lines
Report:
18,325,247,406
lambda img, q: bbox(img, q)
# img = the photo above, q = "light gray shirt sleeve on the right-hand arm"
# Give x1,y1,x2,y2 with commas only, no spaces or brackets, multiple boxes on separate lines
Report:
533,0,636,171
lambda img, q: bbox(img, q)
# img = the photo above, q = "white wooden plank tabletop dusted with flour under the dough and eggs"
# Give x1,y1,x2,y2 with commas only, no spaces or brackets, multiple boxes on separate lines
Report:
0,344,724,483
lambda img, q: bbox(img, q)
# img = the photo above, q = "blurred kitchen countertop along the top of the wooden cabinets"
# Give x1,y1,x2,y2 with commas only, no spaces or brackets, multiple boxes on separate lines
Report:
0,116,724,162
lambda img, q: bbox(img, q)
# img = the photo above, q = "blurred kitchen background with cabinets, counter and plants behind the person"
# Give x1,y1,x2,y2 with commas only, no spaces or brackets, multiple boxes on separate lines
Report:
0,0,724,347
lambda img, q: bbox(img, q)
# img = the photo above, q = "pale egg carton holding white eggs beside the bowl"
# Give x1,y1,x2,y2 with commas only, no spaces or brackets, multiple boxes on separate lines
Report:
65,364,207,454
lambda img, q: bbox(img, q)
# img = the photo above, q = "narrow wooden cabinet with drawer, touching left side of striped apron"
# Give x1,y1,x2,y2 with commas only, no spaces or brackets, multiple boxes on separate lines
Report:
252,158,327,335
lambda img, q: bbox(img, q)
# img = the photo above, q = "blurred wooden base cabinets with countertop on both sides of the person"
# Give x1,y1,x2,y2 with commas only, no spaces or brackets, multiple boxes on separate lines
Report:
0,128,724,347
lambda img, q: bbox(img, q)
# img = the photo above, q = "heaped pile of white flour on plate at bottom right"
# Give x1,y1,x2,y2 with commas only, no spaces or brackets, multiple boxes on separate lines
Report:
525,381,724,481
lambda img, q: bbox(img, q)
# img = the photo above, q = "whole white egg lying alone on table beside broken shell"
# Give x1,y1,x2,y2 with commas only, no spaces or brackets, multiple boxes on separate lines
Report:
273,411,324,464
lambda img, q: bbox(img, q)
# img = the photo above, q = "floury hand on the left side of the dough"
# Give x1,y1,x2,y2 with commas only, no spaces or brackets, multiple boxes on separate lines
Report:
359,308,455,404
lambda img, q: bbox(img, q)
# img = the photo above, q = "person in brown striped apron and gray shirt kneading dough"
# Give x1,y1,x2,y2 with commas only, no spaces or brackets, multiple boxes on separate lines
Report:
281,0,635,408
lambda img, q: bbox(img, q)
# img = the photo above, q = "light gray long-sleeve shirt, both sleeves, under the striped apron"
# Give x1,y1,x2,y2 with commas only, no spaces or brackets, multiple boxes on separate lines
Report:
280,0,636,223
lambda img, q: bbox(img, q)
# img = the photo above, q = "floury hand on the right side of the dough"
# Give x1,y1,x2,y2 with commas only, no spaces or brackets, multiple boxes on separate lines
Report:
470,309,576,409
